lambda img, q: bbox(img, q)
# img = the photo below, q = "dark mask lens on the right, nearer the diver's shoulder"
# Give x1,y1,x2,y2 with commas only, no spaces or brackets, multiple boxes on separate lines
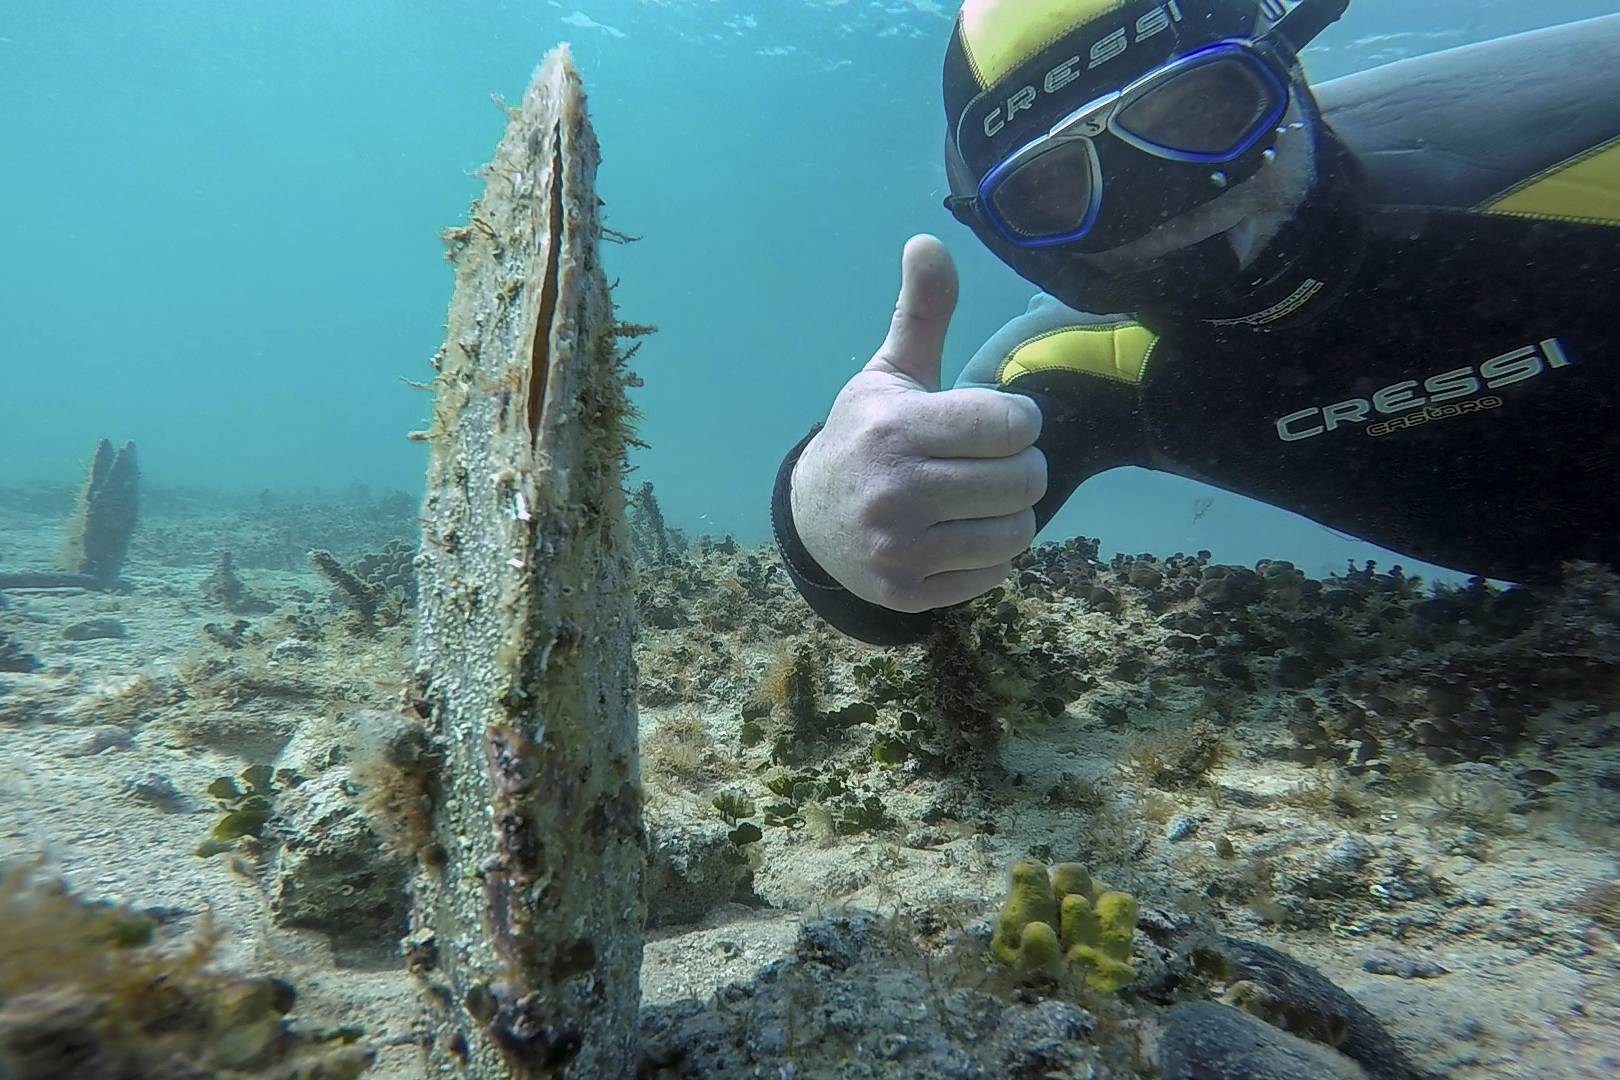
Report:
1115,57,1285,159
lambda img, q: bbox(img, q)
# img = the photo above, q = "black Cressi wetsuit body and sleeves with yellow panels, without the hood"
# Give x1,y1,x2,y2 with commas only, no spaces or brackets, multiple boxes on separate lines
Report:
773,16,1620,644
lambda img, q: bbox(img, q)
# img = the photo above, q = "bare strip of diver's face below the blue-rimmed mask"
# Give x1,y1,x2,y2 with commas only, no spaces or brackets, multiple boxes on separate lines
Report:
1071,92,1315,274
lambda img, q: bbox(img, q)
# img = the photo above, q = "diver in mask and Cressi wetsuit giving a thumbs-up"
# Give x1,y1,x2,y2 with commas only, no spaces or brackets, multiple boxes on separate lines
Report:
771,0,1620,644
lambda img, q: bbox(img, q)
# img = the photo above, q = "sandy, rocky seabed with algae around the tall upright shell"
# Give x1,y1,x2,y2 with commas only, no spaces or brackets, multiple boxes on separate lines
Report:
0,489,1620,1078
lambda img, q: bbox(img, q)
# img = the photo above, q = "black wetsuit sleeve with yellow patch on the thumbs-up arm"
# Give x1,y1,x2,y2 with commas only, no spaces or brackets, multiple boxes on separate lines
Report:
771,295,1153,644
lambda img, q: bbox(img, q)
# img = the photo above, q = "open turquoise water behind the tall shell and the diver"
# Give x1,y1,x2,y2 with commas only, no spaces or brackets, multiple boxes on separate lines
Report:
0,0,1614,572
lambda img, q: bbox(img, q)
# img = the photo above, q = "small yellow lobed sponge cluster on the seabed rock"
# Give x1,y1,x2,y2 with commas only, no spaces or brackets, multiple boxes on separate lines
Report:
990,858,1137,993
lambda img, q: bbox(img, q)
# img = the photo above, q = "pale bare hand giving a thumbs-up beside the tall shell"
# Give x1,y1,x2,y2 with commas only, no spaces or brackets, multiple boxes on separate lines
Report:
792,236,1047,612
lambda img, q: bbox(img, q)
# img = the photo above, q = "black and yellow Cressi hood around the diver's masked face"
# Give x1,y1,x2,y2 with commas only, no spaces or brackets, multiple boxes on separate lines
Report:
944,0,1359,324
